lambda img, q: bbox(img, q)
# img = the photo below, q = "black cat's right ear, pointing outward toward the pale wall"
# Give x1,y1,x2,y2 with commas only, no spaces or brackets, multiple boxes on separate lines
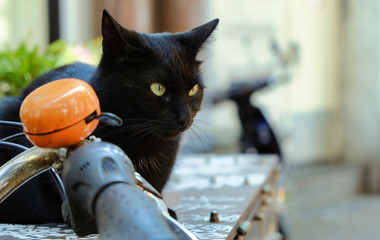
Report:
179,19,219,58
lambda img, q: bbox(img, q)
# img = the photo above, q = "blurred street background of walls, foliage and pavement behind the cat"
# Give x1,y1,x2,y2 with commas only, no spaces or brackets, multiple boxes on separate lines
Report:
0,0,380,239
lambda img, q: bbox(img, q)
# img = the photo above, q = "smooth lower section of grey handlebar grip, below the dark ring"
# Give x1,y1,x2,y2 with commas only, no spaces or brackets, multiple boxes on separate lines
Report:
95,183,176,240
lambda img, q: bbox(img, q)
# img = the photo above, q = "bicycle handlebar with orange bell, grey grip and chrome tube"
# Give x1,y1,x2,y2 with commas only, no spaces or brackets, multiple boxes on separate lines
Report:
0,79,190,240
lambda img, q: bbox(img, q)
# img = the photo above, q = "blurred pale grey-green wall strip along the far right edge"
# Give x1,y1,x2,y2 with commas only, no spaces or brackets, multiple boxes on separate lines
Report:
341,0,380,161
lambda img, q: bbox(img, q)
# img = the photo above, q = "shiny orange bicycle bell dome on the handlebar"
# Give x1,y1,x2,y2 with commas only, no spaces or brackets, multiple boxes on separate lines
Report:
20,78,101,148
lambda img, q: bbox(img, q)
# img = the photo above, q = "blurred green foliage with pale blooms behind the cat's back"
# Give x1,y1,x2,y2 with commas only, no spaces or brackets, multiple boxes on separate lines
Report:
0,38,102,99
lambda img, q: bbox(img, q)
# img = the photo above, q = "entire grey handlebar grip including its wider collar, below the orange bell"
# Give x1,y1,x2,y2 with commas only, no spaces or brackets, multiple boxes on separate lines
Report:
62,142,176,240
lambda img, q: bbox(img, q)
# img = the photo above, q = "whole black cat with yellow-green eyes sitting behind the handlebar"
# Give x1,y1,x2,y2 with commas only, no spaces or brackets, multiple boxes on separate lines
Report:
0,11,219,223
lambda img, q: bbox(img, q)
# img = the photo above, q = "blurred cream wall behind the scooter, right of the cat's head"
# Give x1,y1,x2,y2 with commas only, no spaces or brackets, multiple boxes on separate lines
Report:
208,0,343,163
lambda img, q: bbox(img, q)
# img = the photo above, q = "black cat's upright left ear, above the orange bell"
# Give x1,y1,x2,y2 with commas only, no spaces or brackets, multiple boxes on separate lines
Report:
102,10,139,57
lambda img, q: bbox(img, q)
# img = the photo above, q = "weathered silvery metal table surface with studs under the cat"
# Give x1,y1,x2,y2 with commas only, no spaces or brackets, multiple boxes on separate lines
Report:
0,154,278,240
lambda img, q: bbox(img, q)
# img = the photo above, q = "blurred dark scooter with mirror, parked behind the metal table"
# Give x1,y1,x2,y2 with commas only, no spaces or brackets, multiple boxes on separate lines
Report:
214,42,299,240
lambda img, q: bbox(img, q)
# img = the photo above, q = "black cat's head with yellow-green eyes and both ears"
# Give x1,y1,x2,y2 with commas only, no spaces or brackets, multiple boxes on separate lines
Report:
95,11,219,139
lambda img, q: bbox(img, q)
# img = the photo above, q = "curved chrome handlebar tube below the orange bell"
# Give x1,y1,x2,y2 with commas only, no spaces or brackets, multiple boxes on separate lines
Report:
0,147,60,203
